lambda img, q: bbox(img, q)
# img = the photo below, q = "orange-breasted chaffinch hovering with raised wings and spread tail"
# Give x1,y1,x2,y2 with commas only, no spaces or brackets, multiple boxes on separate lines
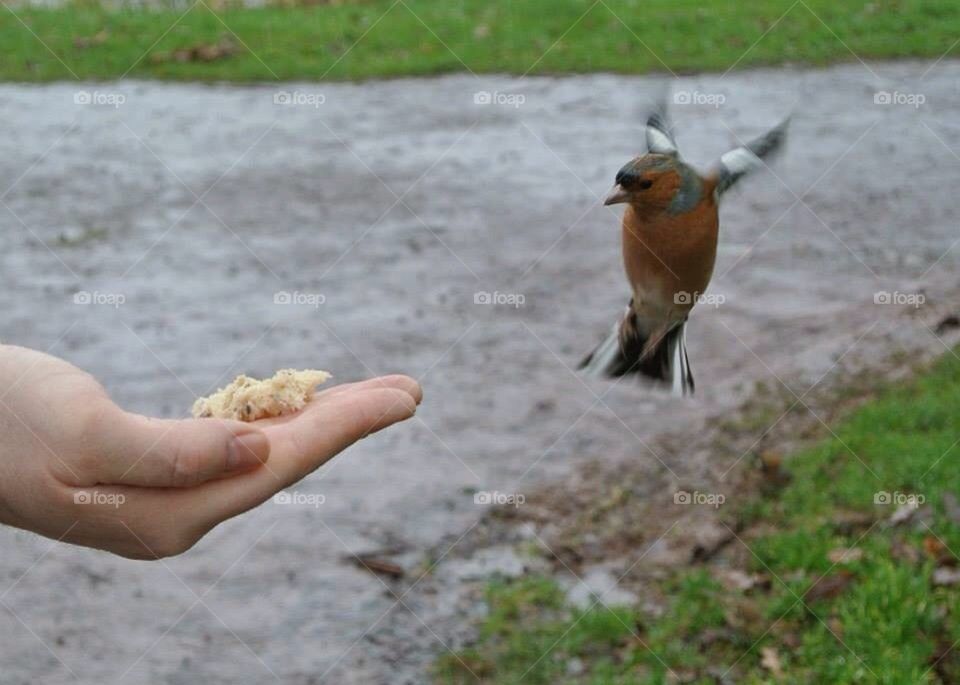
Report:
580,98,789,395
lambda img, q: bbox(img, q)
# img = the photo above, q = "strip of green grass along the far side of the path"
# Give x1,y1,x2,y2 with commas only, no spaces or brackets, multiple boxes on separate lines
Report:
0,0,960,81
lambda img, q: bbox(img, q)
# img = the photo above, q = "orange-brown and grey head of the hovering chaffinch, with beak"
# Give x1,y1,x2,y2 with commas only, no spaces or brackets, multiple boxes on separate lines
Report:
603,152,689,211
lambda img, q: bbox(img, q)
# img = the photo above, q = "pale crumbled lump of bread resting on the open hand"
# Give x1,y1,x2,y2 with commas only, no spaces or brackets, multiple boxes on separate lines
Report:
193,369,330,421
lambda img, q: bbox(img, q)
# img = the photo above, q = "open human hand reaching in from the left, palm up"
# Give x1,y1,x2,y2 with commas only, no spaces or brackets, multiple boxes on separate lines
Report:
0,345,422,559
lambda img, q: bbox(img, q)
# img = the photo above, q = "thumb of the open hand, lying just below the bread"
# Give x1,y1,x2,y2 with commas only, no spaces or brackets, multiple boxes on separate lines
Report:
97,413,270,487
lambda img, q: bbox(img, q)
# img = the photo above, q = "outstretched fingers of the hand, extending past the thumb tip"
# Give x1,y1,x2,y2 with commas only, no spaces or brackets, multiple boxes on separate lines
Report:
193,388,416,527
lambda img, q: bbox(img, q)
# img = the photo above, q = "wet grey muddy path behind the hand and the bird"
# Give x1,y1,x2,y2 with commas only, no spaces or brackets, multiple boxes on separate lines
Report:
0,61,960,683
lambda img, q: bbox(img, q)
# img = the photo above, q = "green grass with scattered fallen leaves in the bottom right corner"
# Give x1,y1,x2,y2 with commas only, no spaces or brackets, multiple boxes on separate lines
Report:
436,353,960,685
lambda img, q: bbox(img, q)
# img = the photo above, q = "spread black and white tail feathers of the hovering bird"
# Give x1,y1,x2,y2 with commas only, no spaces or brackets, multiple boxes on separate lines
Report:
580,308,694,396
